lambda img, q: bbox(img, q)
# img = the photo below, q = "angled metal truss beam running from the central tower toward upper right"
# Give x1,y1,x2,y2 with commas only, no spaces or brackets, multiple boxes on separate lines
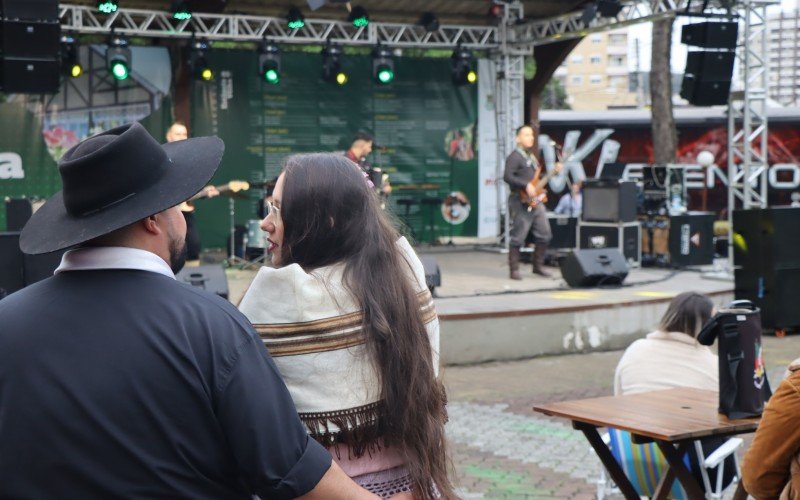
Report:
510,0,736,45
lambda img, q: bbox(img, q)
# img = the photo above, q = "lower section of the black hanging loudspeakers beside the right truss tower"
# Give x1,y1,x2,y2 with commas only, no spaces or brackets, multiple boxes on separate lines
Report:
681,51,735,106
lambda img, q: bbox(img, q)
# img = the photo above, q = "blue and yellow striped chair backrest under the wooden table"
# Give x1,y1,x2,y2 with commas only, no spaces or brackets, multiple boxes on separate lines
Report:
608,429,691,500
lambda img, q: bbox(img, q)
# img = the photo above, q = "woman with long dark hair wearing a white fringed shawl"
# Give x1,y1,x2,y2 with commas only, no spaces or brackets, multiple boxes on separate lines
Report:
240,153,455,499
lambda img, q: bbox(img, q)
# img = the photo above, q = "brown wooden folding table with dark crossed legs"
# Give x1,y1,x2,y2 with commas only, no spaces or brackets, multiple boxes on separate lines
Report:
533,389,759,499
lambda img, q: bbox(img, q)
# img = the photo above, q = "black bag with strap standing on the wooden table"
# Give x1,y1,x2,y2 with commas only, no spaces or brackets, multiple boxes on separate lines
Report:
697,300,772,419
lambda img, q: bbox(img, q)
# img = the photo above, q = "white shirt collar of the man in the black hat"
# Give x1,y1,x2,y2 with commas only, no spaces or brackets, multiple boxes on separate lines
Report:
54,247,175,279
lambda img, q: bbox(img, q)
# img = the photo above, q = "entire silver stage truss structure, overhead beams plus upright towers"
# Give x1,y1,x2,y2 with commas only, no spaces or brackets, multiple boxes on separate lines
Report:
59,0,775,262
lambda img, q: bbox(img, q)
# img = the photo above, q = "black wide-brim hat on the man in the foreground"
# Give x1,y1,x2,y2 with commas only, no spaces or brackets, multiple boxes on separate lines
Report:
19,123,225,254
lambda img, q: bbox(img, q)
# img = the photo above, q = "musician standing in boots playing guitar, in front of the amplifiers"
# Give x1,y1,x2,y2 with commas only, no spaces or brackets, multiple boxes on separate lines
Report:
503,125,553,280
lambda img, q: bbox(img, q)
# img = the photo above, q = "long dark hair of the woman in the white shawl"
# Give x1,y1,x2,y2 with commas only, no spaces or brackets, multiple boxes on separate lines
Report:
281,153,455,499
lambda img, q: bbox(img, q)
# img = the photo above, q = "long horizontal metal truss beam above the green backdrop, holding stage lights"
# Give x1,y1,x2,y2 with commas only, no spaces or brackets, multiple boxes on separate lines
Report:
59,4,500,49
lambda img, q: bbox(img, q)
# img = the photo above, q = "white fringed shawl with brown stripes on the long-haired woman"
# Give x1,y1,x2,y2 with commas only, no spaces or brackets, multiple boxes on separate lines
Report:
239,238,439,456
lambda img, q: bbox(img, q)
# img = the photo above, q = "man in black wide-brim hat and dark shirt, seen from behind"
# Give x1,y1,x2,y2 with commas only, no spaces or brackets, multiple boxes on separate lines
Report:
0,124,378,499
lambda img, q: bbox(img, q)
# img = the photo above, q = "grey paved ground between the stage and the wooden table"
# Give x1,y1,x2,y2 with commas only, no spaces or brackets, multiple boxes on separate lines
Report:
444,336,800,499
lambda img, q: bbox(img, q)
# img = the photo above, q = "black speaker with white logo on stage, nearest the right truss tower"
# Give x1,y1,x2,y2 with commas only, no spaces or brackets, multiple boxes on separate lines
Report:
669,212,714,266
